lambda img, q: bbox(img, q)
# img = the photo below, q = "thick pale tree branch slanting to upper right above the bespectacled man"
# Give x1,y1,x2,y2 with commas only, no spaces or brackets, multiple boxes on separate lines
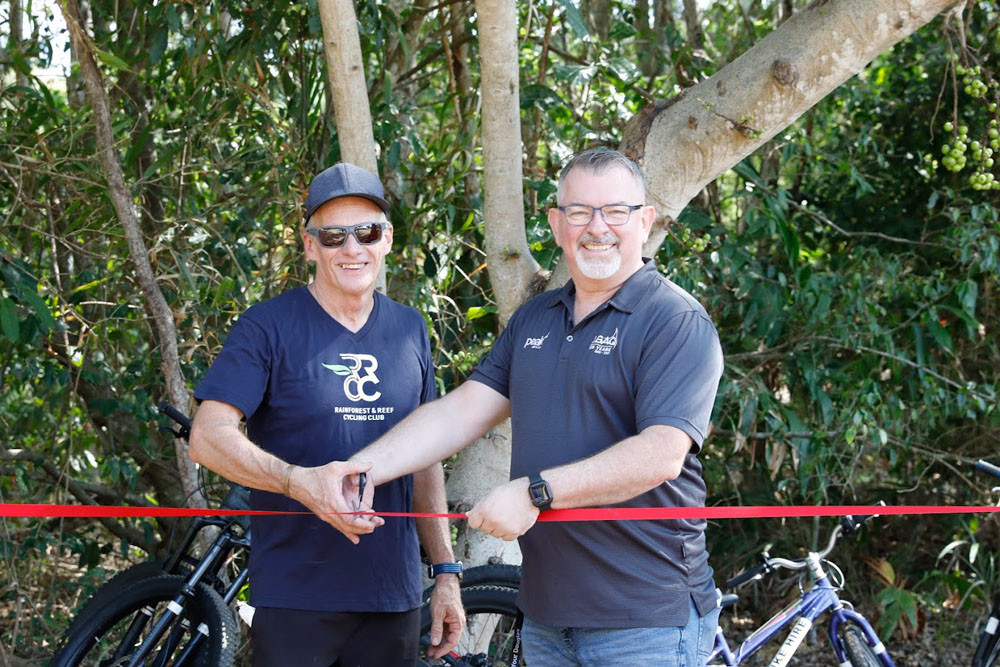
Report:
621,0,957,255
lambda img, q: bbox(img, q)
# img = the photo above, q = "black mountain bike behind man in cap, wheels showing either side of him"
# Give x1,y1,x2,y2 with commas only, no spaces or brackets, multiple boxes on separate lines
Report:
50,403,520,667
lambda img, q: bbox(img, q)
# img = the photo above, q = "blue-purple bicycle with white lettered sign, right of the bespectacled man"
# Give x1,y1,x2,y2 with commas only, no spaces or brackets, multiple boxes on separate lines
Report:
708,508,895,667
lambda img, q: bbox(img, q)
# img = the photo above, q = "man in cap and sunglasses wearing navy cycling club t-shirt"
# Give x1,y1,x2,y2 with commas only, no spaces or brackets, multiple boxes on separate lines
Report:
191,163,465,667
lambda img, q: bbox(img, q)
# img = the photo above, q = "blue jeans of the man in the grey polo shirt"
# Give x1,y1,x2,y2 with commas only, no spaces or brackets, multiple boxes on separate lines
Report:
521,602,719,667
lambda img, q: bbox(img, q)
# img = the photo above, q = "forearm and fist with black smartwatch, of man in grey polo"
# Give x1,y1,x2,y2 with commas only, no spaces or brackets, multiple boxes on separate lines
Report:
469,425,693,541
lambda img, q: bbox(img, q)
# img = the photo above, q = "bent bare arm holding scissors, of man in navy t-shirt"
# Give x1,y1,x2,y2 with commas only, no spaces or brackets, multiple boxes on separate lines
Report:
190,401,384,544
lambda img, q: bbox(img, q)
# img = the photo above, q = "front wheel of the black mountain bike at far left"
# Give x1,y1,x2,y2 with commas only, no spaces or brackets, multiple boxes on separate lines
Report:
51,575,236,667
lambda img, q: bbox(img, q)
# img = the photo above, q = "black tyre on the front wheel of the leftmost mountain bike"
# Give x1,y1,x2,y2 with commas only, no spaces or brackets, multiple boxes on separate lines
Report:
51,575,237,667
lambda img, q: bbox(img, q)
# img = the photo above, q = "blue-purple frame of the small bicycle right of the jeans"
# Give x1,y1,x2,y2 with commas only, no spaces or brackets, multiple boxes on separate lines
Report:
708,553,895,667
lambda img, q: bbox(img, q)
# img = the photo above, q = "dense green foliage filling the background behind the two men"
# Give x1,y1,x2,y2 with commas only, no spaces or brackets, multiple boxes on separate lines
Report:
0,0,1000,652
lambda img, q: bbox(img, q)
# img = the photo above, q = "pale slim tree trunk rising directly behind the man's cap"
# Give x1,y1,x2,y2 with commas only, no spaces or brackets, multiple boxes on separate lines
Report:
319,0,385,292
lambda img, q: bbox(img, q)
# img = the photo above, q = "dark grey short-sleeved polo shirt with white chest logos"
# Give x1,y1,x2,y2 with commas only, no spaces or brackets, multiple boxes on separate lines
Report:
471,260,722,628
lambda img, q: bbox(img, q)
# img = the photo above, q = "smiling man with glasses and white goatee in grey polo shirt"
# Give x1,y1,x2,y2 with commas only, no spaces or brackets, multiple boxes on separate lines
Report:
343,150,722,667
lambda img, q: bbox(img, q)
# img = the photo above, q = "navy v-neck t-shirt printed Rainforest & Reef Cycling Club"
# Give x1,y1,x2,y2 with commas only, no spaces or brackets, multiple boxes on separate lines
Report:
195,287,436,612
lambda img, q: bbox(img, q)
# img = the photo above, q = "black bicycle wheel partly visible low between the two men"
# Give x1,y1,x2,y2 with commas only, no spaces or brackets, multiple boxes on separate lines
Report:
419,586,523,667
